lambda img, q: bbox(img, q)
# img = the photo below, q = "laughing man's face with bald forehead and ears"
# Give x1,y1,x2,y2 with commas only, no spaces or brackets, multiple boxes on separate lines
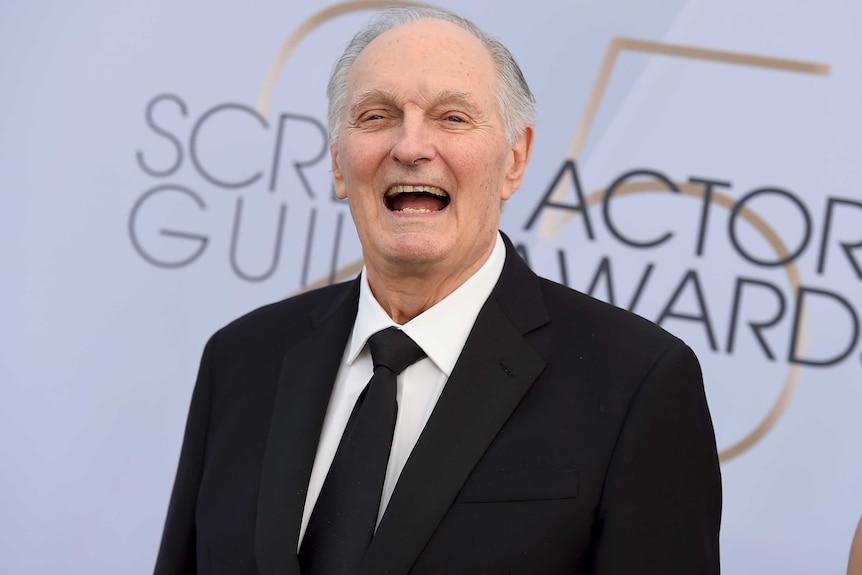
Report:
331,19,532,285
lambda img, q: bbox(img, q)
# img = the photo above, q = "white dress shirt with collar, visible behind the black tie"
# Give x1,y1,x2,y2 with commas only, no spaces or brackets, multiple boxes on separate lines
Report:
299,233,506,543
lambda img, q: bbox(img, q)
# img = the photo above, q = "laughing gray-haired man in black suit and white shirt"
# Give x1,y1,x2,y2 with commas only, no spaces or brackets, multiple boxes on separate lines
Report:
156,8,721,575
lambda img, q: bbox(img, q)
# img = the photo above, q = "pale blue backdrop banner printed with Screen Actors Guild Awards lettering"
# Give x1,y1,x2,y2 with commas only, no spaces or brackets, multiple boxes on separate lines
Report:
5,0,862,575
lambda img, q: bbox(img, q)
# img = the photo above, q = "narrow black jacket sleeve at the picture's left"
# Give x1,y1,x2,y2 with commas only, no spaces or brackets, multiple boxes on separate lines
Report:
155,336,215,575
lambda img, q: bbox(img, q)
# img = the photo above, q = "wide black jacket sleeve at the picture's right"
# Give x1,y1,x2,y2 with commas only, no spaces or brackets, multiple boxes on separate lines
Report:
594,343,721,575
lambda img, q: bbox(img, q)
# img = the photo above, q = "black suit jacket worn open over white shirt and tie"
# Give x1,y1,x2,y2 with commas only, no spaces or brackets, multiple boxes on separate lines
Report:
156,235,721,575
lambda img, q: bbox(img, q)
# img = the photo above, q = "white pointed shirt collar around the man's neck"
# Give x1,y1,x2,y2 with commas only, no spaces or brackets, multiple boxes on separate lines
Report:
347,233,506,377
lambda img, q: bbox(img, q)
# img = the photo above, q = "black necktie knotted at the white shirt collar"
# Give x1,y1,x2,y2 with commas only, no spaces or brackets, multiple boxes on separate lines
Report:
299,327,425,575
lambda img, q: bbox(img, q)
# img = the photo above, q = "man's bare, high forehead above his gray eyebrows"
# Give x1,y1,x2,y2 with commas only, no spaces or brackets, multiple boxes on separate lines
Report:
348,19,496,102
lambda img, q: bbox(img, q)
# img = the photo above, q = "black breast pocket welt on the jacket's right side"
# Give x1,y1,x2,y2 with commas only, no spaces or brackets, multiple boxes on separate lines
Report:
455,469,578,503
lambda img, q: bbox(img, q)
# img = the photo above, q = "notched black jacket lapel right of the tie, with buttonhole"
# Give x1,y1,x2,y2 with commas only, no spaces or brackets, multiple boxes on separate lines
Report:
361,240,548,575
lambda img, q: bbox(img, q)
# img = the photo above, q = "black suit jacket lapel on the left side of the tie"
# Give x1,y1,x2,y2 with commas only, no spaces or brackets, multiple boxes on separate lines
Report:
255,281,359,575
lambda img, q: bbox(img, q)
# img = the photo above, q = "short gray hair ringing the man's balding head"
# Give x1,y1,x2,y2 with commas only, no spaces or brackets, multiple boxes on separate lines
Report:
326,6,536,145
